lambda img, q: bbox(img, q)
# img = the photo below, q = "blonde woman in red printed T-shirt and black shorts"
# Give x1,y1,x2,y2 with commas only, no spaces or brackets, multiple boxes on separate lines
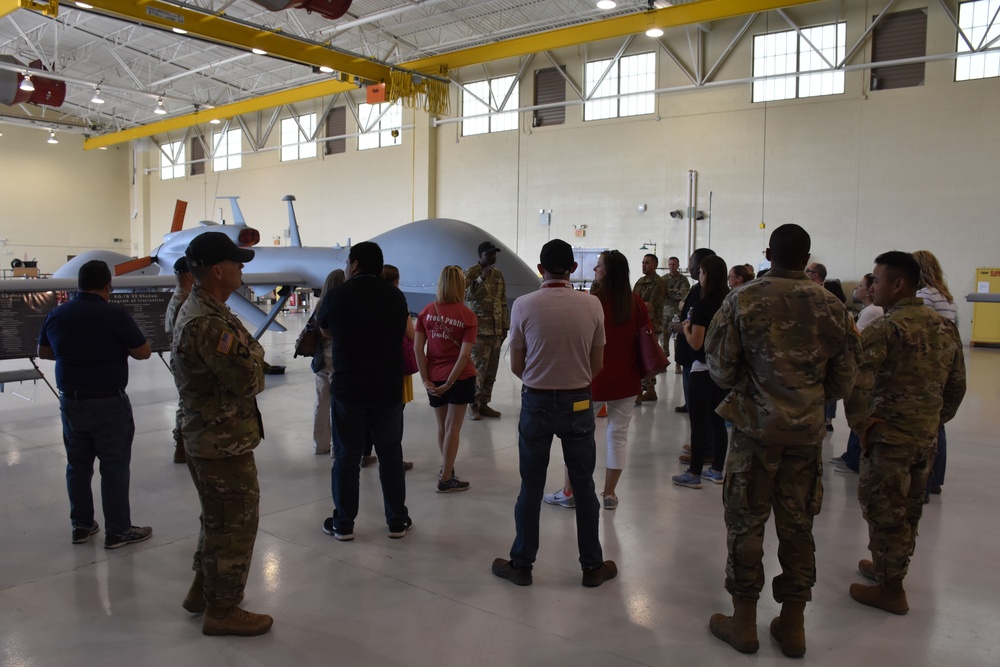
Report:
413,266,479,493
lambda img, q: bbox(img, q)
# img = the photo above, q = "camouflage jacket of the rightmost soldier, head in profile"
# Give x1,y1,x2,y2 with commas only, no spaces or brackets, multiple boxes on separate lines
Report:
845,297,965,447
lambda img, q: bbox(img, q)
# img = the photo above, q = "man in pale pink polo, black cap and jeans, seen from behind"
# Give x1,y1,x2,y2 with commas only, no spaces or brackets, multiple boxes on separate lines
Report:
493,239,618,587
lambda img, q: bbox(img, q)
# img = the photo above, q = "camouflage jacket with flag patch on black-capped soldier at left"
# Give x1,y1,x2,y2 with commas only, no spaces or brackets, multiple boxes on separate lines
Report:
171,286,264,459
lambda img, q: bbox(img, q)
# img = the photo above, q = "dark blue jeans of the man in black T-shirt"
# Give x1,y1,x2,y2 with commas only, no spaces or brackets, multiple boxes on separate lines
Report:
330,397,410,531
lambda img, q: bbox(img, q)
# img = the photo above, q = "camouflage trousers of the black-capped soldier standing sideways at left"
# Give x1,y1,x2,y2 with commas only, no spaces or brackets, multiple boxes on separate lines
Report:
187,452,260,607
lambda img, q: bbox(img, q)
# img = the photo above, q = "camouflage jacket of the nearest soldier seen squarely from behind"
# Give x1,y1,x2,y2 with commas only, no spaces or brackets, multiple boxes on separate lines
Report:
705,269,861,445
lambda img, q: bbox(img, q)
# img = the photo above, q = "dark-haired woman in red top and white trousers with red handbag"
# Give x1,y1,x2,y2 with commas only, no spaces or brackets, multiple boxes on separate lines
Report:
545,250,652,510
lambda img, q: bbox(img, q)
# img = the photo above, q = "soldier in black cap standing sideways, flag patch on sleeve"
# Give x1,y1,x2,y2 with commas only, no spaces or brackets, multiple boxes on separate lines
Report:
171,232,272,636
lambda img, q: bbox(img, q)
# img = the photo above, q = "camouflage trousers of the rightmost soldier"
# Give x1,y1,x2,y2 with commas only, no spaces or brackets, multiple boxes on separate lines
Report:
858,443,935,581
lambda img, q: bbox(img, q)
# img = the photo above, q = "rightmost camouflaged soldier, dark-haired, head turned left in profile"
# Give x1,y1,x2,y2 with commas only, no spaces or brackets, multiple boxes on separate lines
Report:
846,251,965,614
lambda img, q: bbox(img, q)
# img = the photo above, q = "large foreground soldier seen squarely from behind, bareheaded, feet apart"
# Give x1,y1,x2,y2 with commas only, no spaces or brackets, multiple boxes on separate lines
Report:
705,225,860,657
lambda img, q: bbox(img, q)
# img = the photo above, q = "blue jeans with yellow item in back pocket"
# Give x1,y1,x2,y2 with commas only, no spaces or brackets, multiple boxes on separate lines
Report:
510,391,604,570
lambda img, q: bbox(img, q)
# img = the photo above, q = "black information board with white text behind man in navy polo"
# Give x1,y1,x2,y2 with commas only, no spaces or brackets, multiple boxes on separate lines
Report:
0,292,171,359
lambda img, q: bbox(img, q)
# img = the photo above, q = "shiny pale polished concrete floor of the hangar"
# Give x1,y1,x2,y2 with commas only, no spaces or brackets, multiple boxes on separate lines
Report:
0,315,1000,667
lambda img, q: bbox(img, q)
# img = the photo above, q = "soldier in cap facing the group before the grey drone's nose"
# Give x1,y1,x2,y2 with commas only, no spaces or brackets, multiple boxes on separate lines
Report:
465,241,510,421
